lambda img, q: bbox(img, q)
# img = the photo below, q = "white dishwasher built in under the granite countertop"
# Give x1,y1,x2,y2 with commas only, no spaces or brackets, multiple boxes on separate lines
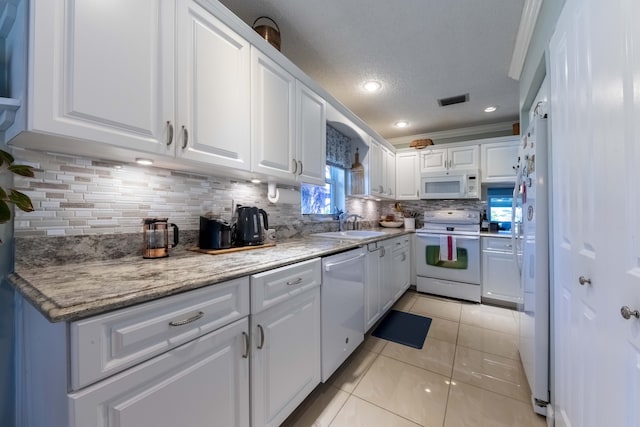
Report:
320,248,365,382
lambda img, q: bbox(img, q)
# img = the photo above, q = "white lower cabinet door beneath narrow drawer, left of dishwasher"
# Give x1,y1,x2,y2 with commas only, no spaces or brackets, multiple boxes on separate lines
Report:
250,287,320,427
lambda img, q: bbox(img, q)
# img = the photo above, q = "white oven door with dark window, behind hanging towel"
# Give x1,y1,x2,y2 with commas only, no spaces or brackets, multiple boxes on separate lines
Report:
416,233,480,285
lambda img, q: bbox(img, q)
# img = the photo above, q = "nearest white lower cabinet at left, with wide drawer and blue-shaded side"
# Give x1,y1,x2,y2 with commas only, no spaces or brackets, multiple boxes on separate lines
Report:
16,277,250,427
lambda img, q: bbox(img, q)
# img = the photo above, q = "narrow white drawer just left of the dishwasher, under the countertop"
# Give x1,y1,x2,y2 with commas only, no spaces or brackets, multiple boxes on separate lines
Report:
251,258,322,314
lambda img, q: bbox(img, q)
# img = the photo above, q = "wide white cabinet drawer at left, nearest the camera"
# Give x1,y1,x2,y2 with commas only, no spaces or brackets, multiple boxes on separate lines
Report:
70,277,249,390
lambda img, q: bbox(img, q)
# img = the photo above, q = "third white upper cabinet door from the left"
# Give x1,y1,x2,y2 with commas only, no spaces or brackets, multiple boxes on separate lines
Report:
251,47,298,180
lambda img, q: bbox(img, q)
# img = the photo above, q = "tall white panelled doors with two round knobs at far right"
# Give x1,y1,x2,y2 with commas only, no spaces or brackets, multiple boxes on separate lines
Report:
550,0,640,427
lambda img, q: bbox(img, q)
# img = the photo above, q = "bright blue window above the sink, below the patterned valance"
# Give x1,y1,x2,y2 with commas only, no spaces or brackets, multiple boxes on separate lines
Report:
300,165,345,215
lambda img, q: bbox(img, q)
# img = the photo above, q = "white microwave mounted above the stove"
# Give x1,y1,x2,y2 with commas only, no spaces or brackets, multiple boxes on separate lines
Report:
420,170,480,199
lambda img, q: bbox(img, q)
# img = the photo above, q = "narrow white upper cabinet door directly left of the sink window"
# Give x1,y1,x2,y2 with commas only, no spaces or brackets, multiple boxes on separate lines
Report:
296,82,327,185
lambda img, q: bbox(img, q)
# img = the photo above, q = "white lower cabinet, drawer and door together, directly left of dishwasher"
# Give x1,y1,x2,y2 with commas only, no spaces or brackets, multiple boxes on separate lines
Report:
251,259,321,427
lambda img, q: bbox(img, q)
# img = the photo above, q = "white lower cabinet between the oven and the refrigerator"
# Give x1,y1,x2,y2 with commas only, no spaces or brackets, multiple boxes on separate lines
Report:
482,237,522,304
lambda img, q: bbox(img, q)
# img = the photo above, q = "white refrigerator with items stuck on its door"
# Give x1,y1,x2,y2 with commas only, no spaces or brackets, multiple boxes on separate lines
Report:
512,102,549,415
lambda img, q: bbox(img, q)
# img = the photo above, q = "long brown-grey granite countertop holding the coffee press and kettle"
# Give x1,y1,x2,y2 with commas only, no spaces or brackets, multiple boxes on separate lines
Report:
9,229,410,322
